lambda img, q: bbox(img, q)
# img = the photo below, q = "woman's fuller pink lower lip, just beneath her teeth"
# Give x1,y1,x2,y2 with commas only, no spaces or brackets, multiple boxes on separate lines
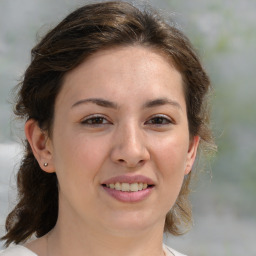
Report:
103,186,153,203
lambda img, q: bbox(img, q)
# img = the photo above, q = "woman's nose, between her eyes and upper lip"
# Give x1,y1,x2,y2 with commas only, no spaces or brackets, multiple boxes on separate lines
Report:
111,124,150,168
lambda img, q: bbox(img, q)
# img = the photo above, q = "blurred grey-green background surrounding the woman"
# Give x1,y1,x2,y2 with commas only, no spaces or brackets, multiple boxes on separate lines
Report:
0,0,256,256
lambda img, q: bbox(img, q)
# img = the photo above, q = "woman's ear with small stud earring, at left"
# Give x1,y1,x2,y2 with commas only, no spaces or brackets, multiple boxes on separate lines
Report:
25,119,55,173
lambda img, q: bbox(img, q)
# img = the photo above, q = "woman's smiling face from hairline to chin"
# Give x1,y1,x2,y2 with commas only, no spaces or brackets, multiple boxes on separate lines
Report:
47,46,198,236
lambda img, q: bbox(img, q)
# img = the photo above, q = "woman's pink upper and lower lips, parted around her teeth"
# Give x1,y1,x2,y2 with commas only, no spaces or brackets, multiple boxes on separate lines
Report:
101,175,155,203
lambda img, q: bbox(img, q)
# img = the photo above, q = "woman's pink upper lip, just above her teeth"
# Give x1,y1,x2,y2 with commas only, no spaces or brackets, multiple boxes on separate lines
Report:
102,175,154,185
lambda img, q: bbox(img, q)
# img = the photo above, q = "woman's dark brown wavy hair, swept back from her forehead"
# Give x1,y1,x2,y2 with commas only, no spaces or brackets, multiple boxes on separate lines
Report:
1,1,214,246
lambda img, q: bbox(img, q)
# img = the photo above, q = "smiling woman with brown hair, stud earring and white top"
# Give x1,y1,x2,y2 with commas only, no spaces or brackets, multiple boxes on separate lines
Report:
0,2,213,256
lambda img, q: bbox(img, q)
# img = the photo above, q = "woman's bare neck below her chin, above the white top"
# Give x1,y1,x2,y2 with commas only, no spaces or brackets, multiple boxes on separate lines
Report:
47,214,164,256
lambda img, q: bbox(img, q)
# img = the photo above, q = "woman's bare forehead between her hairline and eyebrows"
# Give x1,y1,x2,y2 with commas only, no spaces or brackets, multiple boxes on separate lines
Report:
57,46,183,109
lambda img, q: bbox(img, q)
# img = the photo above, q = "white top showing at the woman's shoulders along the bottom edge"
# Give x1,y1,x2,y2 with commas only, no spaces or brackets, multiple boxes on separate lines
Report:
0,245,185,256
